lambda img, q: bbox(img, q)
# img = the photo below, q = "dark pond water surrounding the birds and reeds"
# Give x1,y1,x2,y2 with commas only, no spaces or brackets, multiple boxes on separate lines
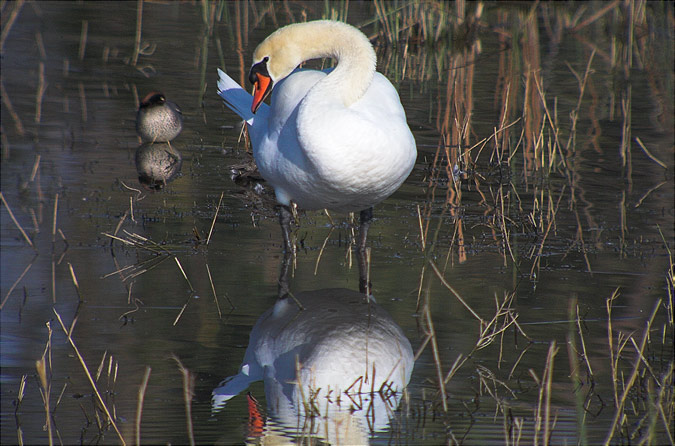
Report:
0,2,675,444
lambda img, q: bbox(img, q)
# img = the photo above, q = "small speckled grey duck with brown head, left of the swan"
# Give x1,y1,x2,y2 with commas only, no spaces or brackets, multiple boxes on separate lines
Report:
136,91,183,142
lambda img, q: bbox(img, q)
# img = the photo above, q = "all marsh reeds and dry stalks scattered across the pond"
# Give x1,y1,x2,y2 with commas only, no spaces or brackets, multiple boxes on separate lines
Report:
0,0,675,445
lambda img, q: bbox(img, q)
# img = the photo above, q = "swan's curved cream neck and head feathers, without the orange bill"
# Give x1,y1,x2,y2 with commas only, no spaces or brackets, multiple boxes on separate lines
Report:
254,20,376,106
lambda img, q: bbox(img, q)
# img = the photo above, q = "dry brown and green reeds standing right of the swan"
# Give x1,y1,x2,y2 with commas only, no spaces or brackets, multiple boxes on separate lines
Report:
396,1,675,444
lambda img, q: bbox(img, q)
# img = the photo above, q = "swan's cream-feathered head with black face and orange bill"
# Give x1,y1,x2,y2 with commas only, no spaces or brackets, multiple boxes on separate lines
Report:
248,25,304,113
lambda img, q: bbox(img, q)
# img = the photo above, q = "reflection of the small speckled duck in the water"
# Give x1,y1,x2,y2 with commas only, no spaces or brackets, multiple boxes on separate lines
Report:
136,142,183,190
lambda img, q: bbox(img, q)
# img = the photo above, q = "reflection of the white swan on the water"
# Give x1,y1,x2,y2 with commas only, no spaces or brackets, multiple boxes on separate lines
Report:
212,289,414,444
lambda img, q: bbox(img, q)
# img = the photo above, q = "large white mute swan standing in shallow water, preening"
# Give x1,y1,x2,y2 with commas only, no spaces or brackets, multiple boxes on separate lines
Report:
218,20,417,249
